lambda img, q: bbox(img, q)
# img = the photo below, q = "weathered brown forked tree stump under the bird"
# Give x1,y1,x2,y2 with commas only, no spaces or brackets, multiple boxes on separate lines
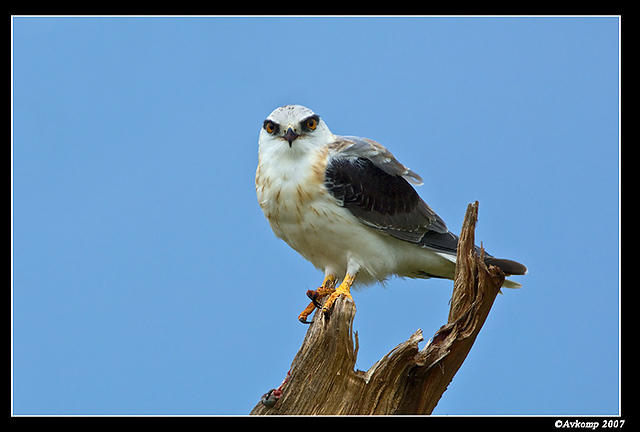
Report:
251,201,504,415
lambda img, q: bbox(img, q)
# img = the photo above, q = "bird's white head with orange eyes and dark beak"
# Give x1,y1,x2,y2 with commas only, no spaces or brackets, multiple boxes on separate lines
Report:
258,105,334,157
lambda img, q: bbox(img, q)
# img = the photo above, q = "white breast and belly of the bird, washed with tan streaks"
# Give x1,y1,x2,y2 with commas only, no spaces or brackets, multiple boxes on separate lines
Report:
256,139,456,284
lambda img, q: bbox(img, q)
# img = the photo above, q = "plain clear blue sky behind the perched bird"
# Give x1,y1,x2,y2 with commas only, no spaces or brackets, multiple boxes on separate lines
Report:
12,17,620,415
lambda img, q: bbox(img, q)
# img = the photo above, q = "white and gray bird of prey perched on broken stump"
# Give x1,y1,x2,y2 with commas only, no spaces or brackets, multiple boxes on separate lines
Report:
255,105,527,323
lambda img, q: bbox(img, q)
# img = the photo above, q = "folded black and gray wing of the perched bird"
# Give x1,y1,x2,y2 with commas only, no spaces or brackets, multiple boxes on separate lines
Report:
325,136,458,248
